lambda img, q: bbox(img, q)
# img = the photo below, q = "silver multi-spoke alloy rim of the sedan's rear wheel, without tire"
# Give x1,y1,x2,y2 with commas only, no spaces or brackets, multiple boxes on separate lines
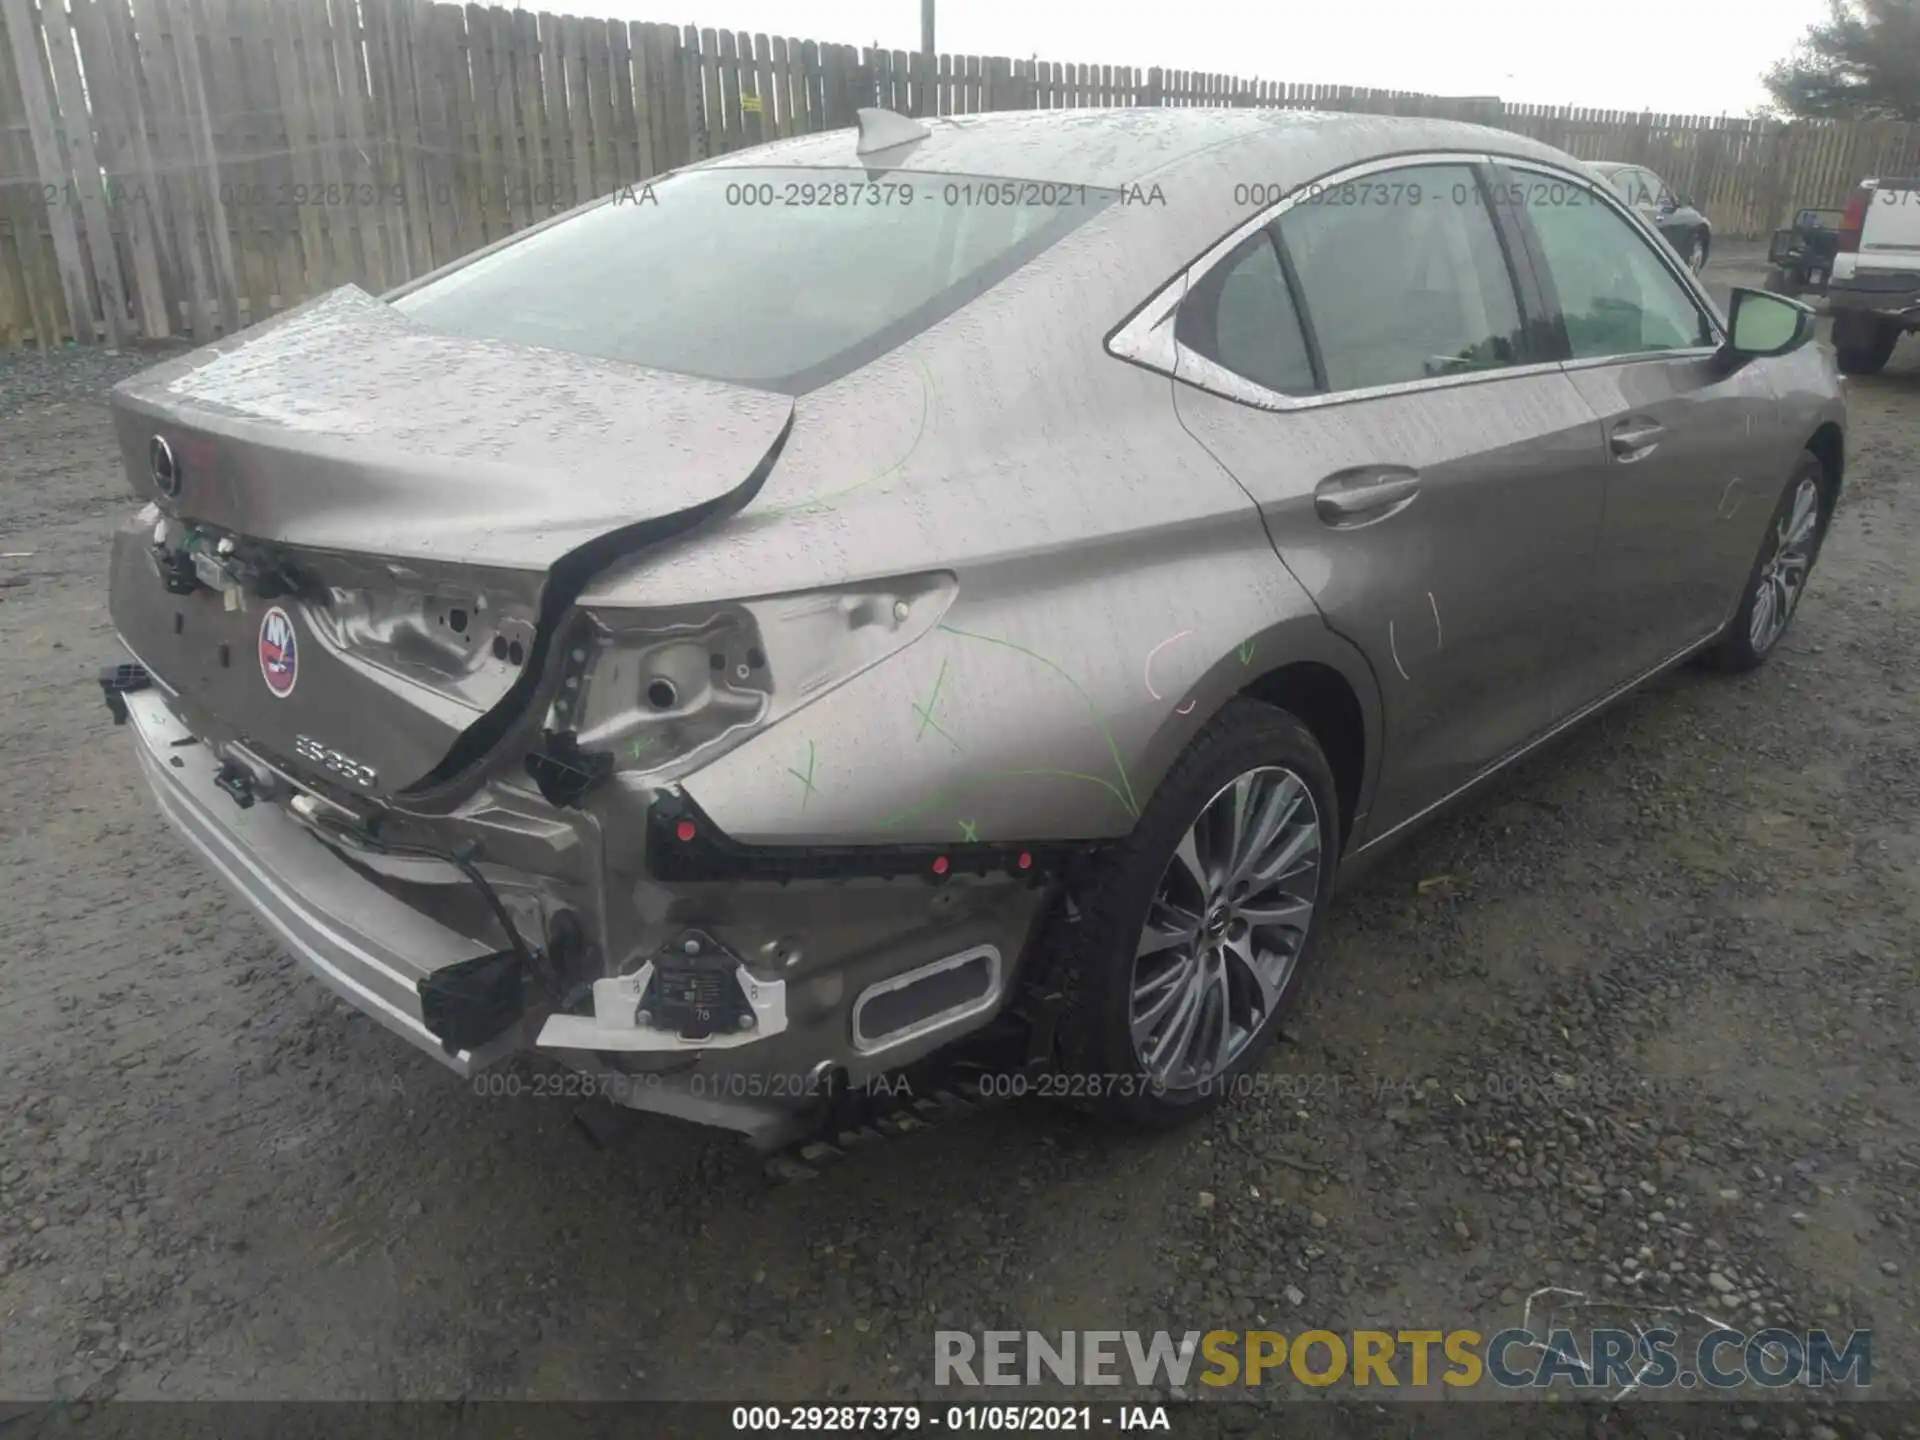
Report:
1129,766,1321,1091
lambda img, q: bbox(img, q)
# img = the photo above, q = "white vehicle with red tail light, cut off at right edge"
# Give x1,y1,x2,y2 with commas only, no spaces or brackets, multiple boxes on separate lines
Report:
1828,179,1920,374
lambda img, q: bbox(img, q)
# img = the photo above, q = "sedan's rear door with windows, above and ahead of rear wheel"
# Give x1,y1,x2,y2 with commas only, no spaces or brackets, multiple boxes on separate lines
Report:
1175,156,1603,835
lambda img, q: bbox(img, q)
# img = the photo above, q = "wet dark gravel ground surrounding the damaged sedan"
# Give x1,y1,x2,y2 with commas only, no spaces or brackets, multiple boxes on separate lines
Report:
0,253,1920,1434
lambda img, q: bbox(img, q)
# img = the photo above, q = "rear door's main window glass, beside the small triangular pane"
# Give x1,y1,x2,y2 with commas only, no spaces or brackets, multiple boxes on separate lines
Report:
1279,165,1524,392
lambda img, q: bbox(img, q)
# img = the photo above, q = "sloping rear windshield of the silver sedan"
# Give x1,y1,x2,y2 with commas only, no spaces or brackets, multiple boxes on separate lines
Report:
394,167,1114,394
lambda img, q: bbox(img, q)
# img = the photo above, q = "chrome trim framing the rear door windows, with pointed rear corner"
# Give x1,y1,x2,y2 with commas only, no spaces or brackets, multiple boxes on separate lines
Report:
1106,150,1561,413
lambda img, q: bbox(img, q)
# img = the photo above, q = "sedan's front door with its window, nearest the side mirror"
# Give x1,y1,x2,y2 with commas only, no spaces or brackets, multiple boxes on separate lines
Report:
1503,163,1784,708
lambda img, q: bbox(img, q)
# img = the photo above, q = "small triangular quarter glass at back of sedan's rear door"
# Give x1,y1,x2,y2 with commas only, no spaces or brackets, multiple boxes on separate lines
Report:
1173,230,1319,396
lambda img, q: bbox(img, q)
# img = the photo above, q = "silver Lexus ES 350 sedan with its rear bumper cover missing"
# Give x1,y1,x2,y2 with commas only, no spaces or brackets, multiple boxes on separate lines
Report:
100,109,1845,1144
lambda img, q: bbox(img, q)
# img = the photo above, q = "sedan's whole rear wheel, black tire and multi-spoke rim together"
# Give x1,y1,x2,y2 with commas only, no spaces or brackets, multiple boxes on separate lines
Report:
1050,699,1340,1127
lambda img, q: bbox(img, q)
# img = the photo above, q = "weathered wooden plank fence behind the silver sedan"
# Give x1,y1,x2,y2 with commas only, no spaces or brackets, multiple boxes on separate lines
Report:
0,0,1920,346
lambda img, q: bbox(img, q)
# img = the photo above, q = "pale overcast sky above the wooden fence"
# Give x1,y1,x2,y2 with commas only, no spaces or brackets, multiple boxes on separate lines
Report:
560,0,1826,115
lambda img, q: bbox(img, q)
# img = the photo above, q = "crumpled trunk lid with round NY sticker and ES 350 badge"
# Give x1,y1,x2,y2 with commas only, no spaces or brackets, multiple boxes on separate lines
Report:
111,288,793,797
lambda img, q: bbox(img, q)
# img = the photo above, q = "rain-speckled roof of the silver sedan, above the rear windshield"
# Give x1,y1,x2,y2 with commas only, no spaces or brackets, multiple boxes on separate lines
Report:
703,108,1578,188
